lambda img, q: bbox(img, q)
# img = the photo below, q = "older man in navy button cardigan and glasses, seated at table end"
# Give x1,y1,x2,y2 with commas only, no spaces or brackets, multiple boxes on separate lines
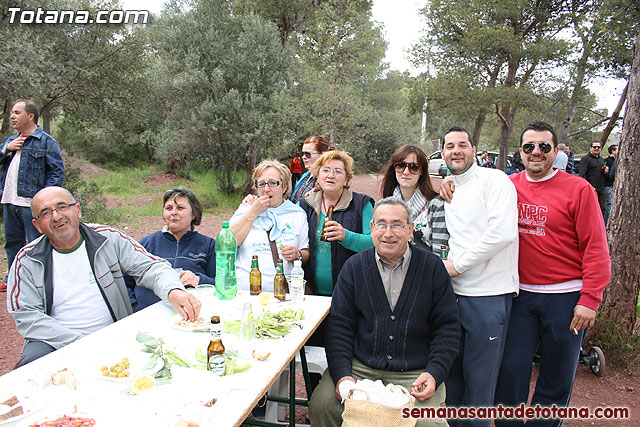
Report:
309,196,460,427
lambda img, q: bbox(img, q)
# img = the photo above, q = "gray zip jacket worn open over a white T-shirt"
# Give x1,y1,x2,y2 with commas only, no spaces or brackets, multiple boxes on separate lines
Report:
7,223,184,349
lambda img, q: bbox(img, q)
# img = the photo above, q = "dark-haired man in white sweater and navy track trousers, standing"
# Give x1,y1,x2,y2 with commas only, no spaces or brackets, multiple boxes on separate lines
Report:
442,126,518,427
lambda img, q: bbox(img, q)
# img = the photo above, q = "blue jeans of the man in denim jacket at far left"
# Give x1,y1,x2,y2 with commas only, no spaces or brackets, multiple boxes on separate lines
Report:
2,204,40,269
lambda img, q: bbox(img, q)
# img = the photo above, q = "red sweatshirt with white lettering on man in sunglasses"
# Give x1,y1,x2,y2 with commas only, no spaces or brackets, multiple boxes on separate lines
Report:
510,171,611,310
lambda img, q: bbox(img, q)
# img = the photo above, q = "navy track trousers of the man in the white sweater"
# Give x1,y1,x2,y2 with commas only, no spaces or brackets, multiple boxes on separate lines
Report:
445,294,513,427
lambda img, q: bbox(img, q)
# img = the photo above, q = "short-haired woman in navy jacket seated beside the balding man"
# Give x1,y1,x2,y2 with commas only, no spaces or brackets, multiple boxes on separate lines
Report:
125,188,216,311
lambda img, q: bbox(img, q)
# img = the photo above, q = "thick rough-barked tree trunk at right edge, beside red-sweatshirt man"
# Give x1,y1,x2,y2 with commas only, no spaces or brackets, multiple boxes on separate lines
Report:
600,34,640,336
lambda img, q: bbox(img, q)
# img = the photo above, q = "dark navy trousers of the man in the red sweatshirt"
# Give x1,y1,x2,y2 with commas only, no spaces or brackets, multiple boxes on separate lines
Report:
495,291,584,427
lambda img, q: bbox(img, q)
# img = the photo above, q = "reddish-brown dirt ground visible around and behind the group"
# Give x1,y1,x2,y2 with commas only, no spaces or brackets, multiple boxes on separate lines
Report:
0,175,640,427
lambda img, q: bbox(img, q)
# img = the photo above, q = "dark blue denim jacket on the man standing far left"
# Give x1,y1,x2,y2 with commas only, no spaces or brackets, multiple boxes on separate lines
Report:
0,126,64,201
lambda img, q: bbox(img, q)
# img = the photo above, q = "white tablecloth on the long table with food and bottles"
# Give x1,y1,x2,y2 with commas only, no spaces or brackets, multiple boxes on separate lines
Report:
0,294,331,427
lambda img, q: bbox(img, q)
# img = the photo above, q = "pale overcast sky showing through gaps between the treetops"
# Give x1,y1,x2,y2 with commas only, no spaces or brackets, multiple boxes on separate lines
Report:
122,0,626,112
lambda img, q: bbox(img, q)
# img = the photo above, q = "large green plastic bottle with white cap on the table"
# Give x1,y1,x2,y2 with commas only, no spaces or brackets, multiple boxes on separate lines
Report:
216,221,238,300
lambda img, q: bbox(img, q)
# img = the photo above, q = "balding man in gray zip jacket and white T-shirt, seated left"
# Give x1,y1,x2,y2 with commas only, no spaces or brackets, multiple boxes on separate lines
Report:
7,187,200,367
